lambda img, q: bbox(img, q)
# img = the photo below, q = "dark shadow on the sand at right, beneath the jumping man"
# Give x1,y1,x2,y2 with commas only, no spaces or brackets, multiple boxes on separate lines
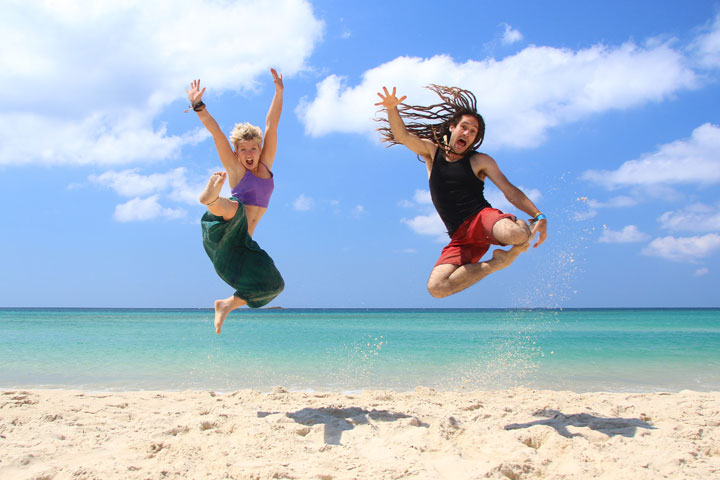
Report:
505,410,655,438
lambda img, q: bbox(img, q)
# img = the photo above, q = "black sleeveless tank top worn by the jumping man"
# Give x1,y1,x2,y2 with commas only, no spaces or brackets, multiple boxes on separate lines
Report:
430,147,490,237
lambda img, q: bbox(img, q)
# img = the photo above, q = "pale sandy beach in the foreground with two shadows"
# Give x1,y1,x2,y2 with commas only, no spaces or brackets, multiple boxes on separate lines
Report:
0,387,720,480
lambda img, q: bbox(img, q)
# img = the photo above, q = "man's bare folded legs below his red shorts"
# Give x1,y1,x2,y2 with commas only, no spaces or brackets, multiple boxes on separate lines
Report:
427,218,531,298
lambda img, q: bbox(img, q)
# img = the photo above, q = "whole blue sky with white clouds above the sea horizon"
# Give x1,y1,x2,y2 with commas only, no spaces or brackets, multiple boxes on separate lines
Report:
0,0,720,307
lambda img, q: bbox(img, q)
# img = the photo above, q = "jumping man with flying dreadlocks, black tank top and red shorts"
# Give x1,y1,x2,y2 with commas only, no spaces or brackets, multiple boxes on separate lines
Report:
375,85,547,298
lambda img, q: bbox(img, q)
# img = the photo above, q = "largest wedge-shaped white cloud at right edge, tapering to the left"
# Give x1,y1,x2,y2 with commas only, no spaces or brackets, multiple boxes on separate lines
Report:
582,123,720,188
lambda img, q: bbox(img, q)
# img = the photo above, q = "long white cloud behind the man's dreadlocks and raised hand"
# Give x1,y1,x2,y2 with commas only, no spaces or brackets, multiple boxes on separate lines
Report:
296,38,696,148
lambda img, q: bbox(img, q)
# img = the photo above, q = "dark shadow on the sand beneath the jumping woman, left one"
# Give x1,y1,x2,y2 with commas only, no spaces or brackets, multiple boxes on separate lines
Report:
257,407,430,445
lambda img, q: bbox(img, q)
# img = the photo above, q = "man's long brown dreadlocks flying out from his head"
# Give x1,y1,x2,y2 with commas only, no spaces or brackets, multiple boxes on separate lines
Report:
377,84,485,157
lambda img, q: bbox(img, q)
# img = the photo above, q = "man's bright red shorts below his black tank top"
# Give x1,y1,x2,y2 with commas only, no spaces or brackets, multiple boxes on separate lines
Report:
435,207,517,267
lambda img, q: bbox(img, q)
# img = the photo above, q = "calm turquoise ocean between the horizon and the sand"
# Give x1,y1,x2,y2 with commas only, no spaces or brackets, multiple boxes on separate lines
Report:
0,308,720,392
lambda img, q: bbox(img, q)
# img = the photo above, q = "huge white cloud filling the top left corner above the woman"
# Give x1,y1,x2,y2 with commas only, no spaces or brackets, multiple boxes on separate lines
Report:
0,0,323,165
